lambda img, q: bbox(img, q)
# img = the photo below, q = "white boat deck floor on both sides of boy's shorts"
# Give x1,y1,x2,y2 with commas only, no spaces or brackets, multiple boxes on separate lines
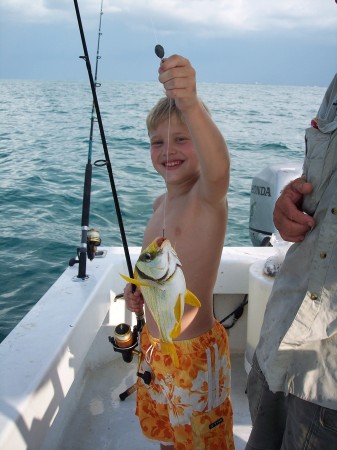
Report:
60,354,251,450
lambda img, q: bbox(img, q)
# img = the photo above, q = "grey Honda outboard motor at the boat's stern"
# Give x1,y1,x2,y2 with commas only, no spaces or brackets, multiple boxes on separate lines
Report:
249,164,302,247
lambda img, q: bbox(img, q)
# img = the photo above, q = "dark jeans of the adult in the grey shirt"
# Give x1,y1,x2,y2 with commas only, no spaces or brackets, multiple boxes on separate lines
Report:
246,355,337,450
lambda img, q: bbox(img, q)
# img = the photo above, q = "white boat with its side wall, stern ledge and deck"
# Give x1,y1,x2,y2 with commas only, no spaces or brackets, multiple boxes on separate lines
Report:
0,247,274,450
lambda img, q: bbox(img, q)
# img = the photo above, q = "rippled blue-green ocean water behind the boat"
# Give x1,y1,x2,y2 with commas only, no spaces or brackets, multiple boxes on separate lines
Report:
0,80,325,341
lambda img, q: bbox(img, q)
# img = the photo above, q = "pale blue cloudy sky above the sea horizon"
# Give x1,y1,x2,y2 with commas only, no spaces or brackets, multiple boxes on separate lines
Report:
0,0,337,87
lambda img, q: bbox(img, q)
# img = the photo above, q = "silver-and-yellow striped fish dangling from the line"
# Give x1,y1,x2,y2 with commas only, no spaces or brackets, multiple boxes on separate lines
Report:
120,237,201,367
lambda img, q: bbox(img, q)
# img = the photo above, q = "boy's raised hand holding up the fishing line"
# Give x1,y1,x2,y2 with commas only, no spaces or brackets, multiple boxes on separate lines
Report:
158,55,198,112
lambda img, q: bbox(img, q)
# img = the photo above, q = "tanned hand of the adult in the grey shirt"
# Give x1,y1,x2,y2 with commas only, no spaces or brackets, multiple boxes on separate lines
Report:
273,177,315,242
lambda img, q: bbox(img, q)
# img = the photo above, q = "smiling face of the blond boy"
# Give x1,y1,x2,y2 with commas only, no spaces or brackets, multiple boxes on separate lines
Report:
149,114,199,184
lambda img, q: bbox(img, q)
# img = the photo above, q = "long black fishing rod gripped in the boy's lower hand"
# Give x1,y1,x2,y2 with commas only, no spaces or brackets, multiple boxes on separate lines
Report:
74,0,144,330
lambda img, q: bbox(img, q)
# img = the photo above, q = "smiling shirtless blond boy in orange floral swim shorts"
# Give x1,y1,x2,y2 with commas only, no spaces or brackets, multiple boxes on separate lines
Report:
124,55,234,450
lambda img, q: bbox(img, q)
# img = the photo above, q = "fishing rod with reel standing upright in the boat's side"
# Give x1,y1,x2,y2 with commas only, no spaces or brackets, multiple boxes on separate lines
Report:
70,0,103,279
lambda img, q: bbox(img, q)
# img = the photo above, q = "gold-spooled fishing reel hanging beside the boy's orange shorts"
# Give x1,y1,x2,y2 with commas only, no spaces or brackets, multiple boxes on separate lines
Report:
109,323,152,400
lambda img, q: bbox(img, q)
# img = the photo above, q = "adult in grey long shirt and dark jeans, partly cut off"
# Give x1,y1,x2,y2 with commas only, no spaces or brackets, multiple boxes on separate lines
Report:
246,74,337,450
